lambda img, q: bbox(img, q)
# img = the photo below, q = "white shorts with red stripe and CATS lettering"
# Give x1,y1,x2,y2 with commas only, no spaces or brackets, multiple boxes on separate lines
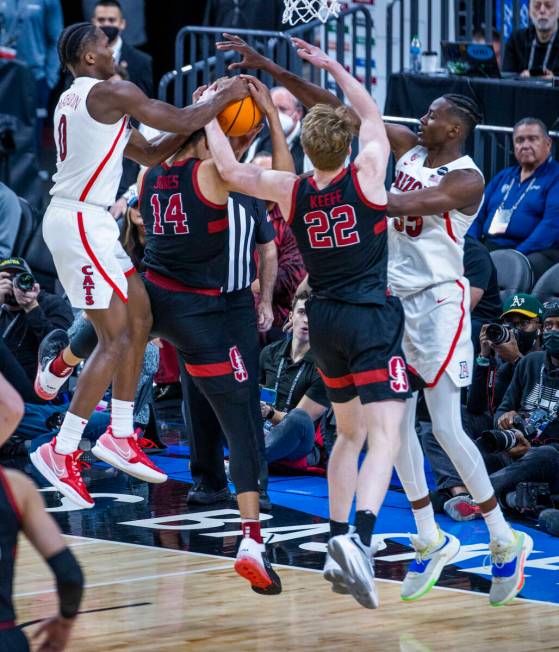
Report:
43,197,135,310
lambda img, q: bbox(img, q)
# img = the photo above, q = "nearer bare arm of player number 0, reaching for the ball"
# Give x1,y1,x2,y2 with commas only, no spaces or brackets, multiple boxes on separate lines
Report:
87,77,248,137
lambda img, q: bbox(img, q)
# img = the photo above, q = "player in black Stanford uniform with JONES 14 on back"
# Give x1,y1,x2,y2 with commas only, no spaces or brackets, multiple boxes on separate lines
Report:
140,80,290,594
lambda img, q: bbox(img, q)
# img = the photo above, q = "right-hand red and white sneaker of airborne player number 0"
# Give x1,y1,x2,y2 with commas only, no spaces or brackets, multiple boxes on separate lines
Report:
91,426,167,483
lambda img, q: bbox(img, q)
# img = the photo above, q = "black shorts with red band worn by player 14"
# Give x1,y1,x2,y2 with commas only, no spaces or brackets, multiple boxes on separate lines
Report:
144,279,248,395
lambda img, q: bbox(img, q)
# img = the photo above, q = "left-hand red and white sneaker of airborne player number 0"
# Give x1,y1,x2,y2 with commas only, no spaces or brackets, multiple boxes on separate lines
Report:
30,437,95,509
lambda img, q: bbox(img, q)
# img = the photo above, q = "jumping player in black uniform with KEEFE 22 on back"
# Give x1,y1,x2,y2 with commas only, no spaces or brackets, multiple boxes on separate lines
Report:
206,39,410,608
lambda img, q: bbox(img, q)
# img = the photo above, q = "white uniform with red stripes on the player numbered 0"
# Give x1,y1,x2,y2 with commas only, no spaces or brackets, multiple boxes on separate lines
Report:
43,77,134,309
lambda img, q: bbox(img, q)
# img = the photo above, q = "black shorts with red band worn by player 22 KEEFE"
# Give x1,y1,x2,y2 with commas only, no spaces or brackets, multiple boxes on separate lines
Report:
307,297,411,404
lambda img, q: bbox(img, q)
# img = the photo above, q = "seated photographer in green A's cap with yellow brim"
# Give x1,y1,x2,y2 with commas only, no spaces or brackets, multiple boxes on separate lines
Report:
421,294,543,520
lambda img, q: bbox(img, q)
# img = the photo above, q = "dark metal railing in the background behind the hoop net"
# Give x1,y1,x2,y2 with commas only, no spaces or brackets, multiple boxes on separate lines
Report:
158,7,373,106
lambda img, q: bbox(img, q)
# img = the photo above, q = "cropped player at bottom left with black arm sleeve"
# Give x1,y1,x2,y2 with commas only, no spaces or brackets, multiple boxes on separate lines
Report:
0,374,83,652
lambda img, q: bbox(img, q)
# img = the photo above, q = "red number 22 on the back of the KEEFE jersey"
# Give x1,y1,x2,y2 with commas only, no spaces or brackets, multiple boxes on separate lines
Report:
303,204,360,249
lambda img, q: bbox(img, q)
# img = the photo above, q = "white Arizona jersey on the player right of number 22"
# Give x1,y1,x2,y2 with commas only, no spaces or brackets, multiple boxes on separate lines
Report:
388,146,483,296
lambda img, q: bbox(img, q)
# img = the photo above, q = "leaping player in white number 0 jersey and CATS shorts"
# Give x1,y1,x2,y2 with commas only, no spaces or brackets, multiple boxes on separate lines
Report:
31,23,248,507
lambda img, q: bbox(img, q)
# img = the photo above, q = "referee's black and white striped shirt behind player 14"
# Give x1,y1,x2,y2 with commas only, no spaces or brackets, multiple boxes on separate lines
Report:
225,192,276,292
